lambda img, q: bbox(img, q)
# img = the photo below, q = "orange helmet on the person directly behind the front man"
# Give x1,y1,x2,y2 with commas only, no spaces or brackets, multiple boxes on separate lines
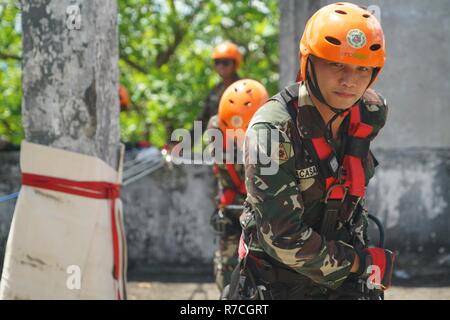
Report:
218,79,269,133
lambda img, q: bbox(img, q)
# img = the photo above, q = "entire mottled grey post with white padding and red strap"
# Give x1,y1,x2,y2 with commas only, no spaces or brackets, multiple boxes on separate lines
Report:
0,0,126,299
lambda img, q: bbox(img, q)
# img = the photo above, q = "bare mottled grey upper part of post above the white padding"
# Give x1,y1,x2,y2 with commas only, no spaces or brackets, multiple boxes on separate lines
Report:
22,0,119,168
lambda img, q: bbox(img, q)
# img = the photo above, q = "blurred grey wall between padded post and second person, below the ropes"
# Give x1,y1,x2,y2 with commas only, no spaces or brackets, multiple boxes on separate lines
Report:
122,165,216,272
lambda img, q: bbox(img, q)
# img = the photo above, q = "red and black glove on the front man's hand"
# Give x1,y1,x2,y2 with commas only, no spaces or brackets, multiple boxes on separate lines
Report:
358,248,395,290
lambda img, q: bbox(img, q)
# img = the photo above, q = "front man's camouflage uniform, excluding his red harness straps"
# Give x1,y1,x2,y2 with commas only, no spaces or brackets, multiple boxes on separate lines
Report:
241,83,387,299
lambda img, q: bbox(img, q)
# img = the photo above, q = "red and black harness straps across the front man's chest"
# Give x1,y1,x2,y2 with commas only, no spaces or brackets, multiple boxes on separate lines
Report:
271,83,373,239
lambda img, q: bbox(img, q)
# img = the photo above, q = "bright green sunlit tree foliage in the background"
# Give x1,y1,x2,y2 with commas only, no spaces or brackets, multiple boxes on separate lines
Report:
0,0,279,145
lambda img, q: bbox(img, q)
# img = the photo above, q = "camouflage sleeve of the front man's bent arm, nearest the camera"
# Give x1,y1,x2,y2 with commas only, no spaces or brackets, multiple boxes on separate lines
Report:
245,123,355,289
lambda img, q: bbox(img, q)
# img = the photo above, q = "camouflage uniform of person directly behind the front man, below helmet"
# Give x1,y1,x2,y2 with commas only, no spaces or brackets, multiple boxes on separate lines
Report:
208,115,246,292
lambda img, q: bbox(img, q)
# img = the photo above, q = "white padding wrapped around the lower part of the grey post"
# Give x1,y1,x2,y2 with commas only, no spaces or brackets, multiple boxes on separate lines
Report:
0,142,126,299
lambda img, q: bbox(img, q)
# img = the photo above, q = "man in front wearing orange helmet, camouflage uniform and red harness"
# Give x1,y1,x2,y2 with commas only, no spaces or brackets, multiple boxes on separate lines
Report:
234,3,394,299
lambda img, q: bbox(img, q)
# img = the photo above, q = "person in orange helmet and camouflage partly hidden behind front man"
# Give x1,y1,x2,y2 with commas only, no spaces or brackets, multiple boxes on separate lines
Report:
208,79,268,292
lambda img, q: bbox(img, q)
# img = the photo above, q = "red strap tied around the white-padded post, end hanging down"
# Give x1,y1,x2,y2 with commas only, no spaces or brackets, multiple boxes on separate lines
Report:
22,173,121,300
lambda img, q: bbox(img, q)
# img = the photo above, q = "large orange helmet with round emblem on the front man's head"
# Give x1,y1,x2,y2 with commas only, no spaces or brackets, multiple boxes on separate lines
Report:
297,2,385,84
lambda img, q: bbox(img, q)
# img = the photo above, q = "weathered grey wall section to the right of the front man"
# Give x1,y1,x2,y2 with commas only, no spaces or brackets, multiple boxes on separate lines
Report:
366,148,450,250
